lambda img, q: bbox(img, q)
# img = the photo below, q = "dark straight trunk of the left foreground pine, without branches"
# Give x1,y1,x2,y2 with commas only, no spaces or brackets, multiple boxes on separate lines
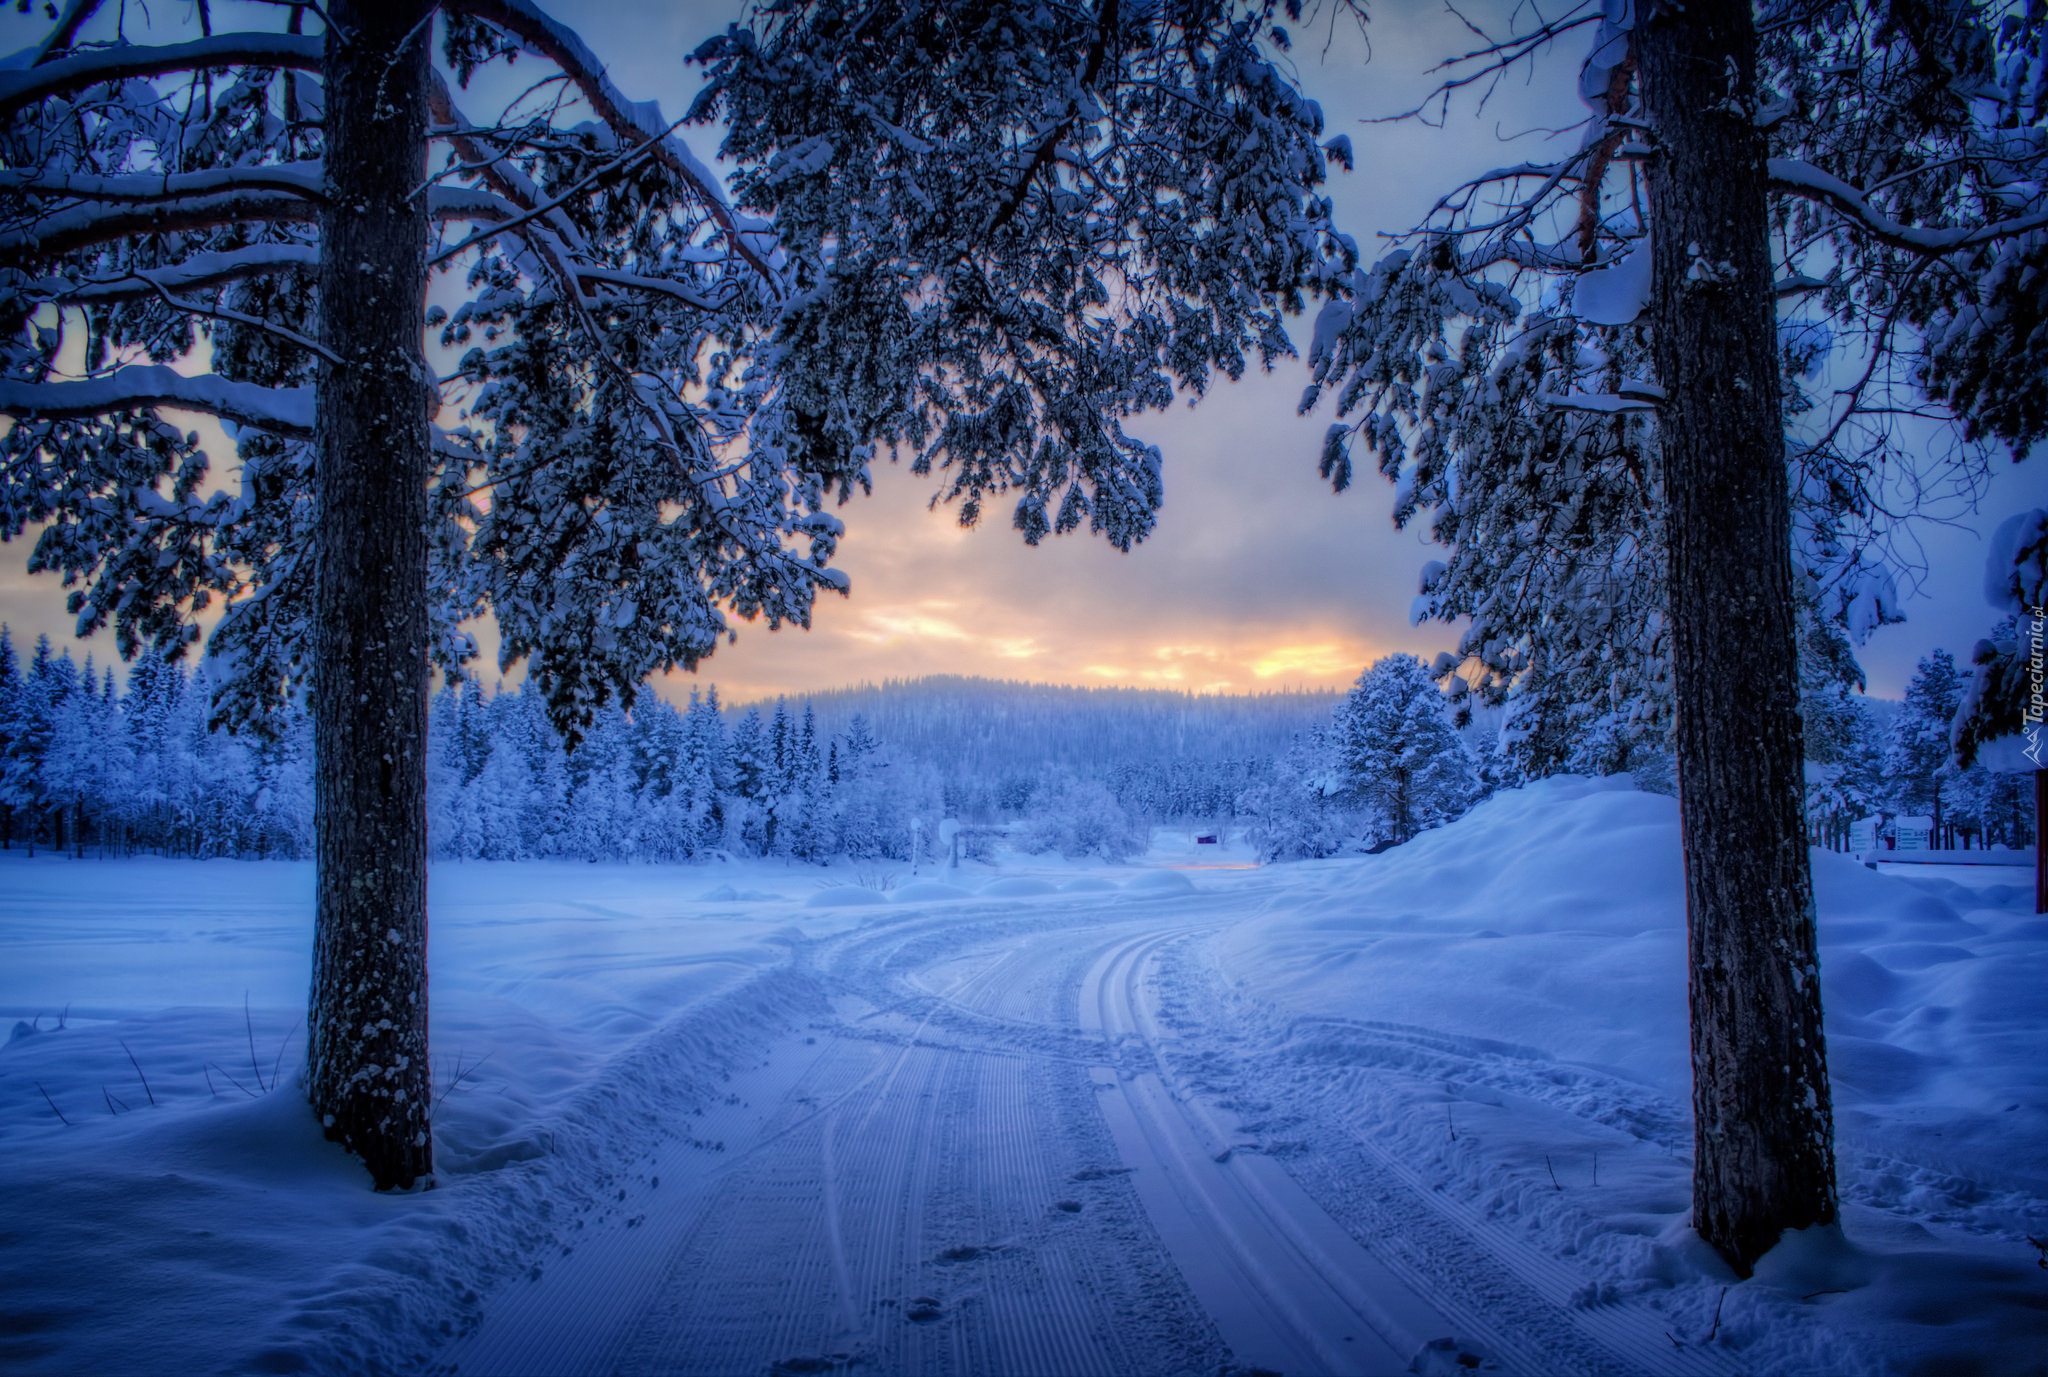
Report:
307,0,434,1188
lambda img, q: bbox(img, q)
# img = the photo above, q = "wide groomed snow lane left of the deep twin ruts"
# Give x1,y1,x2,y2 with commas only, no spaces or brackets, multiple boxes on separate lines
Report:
440,912,1225,1377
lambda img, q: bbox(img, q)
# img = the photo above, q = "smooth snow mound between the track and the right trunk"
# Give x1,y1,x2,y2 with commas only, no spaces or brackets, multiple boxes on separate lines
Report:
1221,779,1690,1096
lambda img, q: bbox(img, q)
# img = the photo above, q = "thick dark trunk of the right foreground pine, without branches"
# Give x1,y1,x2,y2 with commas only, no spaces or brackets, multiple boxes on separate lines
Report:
1636,0,1835,1277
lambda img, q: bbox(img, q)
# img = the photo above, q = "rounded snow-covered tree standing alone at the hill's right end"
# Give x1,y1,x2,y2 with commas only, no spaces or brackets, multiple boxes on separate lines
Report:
1329,656,1479,844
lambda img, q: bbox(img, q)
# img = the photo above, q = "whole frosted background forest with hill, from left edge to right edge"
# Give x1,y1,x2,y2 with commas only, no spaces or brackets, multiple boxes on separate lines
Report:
0,627,2032,863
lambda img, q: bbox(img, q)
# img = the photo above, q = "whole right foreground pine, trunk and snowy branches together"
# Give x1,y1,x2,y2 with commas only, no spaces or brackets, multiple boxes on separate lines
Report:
1313,0,2048,1272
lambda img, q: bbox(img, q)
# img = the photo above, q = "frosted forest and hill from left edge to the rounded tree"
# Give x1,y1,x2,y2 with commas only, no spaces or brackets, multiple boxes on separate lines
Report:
0,629,1341,861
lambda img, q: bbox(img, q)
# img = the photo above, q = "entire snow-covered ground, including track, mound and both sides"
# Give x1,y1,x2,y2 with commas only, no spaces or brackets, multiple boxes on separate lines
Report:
0,781,2048,1375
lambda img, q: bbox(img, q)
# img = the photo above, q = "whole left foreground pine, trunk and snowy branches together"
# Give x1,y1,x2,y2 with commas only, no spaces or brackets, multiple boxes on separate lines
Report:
0,0,844,1186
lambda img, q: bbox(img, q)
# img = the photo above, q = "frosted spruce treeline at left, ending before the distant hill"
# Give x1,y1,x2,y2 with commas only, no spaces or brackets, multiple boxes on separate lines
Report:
0,627,940,861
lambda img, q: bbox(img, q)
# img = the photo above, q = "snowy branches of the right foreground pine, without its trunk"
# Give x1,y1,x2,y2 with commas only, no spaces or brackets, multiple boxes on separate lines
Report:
1305,4,2048,768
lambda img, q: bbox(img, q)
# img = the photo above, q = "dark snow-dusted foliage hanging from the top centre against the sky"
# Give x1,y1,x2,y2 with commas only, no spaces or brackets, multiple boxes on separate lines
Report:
692,0,1354,549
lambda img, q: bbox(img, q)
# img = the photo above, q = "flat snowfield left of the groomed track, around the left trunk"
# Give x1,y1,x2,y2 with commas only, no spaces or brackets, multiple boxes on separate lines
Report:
0,852,835,1373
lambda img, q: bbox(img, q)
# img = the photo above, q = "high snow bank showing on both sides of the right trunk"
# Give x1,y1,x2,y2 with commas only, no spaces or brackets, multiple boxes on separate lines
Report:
1212,777,2015,1113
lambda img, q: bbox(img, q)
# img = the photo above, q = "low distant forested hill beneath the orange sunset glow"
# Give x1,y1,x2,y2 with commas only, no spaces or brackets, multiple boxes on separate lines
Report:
737,674,1343,777
